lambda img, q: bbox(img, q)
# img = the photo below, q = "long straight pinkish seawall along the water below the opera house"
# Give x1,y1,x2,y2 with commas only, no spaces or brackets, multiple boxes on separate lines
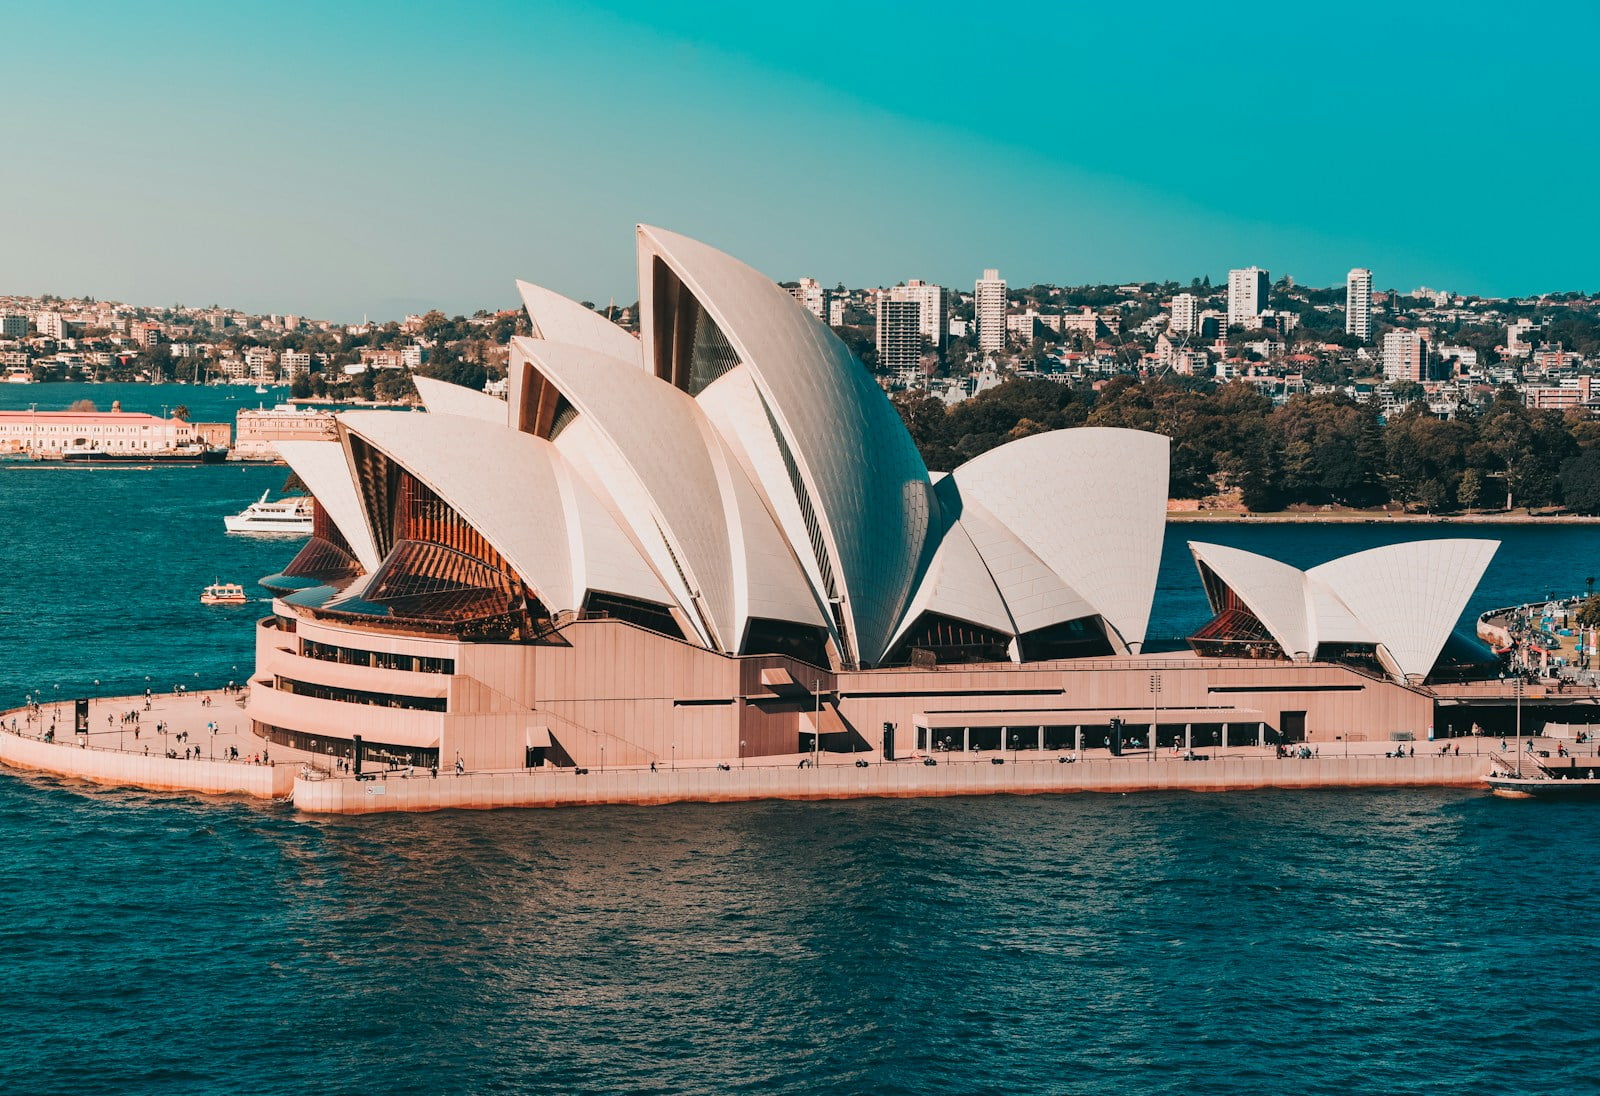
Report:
294,755,1488,814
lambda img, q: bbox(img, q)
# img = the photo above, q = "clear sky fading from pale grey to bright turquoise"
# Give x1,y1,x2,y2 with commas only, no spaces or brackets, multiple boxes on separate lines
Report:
0,0,1600,320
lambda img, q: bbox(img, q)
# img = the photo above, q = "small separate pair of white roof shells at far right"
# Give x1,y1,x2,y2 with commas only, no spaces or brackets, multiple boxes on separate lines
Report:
1189,538,1499,678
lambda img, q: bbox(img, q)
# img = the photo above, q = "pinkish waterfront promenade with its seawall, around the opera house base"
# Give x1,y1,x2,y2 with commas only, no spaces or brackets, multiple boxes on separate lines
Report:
0,691,1574,814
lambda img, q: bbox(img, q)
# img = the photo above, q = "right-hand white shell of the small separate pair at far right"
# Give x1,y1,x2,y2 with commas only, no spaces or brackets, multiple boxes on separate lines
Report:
1307,538,1499,677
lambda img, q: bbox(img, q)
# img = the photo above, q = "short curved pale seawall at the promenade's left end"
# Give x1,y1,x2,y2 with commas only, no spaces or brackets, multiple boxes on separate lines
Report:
0,731,299,798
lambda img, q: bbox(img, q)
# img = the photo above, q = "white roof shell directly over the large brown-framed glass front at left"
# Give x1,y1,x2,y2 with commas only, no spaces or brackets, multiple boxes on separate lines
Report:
339,411,670,613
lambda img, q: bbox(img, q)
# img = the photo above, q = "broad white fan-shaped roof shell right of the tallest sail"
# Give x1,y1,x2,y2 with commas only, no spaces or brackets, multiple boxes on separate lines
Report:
950,427,1170,648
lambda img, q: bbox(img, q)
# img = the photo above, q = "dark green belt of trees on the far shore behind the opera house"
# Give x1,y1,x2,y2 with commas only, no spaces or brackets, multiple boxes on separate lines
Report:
893,376,1600,514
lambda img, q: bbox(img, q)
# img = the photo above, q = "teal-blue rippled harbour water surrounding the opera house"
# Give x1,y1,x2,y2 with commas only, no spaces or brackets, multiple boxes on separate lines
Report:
0,386,1600,1094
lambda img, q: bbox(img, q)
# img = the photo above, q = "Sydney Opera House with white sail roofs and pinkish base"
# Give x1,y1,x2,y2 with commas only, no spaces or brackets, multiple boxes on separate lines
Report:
248,227,1494,771
